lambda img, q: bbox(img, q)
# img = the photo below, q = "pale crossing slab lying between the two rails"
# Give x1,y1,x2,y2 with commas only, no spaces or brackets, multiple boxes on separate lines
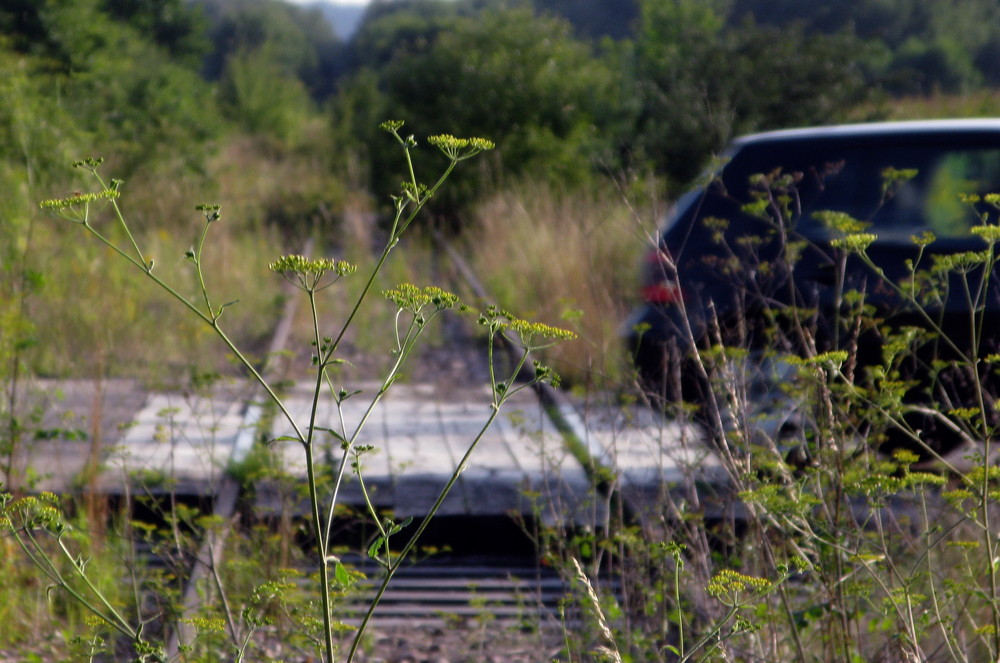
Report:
274,384,589,517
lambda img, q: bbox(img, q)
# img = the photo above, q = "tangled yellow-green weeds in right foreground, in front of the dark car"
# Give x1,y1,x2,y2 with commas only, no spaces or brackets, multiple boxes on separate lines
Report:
538,173,1000,662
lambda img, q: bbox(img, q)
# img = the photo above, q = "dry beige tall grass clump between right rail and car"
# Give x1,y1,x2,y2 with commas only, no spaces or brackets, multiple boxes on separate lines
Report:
466,182,658,386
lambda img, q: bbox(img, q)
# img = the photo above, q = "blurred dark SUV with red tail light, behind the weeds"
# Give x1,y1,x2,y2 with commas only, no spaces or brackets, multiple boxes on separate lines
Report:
625,119,1000,460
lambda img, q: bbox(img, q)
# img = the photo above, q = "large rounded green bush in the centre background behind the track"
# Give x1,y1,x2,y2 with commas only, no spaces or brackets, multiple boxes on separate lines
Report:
336,9,612,218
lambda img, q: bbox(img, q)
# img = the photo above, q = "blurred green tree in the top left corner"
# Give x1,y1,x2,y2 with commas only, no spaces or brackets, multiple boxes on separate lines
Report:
0,0,218,166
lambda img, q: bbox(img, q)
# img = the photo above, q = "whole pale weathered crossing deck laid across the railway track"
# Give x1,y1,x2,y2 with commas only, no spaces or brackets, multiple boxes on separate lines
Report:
5,381,723,522
